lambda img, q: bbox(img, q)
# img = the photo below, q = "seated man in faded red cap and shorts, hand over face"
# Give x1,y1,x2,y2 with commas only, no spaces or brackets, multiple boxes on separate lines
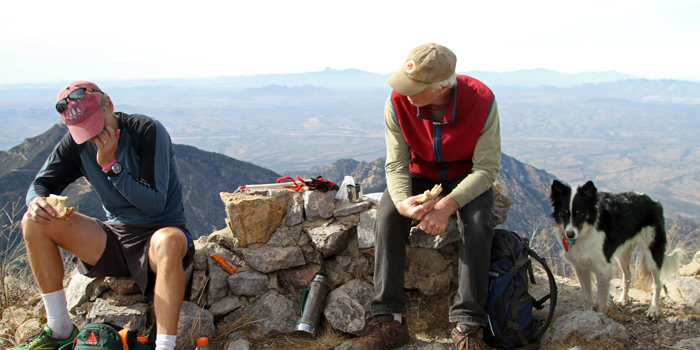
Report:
15,81,194,350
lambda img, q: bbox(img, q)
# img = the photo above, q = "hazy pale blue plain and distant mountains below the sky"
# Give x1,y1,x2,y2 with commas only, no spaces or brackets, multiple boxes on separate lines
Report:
0,69,700,223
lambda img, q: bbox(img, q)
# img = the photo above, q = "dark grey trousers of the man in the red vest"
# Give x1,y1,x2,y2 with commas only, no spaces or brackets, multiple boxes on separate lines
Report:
371,174,494,326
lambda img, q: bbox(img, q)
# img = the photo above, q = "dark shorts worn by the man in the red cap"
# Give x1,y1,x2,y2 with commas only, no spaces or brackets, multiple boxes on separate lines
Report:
73,219,194,299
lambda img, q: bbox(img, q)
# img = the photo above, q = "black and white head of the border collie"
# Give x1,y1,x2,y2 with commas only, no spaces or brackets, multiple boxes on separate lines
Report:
549,180,598,239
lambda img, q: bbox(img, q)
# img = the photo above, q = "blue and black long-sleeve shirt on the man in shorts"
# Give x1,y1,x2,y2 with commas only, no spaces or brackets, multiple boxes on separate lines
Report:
26,112,187,225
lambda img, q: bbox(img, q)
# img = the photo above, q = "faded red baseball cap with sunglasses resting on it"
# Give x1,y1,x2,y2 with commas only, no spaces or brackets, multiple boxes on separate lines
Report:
56,80,104,144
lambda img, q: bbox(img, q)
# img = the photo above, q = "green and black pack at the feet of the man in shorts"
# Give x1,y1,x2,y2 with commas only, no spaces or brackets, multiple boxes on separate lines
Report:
59,322,155,350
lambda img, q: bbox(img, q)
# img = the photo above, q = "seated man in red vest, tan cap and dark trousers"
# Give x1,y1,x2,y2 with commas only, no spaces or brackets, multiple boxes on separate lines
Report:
352,43,501,350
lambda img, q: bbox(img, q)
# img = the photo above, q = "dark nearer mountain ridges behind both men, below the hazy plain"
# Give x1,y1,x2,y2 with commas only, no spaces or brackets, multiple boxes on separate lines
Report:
0,123,554,241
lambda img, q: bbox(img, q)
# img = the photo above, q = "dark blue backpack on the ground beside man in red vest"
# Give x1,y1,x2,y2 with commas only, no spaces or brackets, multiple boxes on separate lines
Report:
484,229,557,349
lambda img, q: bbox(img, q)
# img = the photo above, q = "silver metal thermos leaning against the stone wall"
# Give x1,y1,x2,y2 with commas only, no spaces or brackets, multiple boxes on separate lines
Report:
294,272,331,337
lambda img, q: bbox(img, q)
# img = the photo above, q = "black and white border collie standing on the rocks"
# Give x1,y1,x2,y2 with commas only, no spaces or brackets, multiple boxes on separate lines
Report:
550,180,683,318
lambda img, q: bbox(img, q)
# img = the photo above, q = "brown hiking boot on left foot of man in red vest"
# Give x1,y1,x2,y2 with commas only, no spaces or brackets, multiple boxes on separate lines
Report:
350,315,409,350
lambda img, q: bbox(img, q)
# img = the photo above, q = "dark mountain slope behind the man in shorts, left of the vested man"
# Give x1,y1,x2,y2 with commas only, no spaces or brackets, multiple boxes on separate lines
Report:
0,123,279,238
